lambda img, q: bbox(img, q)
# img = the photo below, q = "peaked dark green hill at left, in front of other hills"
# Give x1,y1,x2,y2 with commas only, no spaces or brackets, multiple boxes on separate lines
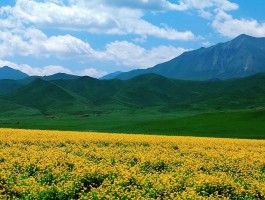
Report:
3,79,92,115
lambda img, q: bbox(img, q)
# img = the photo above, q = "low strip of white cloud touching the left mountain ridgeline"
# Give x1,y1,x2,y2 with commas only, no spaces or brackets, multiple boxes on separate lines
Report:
0,59,107,78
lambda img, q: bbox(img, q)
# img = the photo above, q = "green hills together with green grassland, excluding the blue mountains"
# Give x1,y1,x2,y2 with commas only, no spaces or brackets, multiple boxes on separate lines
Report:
0,73,265,139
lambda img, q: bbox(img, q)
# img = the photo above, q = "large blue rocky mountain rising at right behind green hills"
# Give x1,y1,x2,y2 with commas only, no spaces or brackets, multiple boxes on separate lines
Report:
114,35,265,80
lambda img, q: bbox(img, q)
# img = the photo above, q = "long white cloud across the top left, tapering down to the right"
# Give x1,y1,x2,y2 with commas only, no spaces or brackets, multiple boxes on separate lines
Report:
0,0,195,40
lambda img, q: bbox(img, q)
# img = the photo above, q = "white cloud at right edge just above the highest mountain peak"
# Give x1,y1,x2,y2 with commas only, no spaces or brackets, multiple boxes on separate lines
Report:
212,10,265,38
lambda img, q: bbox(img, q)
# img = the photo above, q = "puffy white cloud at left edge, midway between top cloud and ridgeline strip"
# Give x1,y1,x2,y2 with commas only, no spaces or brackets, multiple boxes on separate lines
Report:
0,28,94,58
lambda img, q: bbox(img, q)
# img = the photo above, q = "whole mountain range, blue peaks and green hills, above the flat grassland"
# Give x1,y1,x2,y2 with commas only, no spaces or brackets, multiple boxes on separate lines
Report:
0,35,265,116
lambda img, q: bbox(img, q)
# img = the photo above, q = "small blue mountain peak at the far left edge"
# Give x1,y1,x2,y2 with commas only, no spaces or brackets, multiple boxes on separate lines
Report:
0,66,28,80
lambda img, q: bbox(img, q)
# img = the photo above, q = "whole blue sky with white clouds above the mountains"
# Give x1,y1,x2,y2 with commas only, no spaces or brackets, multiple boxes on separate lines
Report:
0,0,265,78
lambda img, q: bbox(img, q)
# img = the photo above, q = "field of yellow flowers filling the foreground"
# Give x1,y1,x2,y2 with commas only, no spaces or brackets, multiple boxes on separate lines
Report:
0,129,265,199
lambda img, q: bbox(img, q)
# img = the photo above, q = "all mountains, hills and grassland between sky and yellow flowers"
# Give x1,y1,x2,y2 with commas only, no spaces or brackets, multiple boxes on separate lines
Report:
0,35,265,139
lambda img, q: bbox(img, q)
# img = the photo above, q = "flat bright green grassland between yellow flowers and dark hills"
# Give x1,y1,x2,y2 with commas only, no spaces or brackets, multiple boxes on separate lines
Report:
0,109,265,139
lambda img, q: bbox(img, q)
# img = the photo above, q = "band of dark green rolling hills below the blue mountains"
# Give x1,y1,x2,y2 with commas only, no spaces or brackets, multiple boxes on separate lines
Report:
3,73,265,115
